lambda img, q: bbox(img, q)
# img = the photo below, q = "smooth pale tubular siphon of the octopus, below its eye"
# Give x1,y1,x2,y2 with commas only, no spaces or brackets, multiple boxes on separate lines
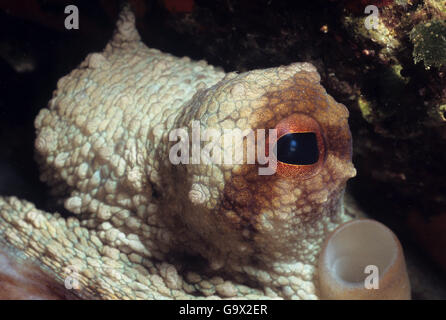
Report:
318,219,411,300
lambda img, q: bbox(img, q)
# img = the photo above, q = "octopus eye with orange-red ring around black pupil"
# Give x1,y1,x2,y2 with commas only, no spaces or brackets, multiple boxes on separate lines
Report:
274,113,325,179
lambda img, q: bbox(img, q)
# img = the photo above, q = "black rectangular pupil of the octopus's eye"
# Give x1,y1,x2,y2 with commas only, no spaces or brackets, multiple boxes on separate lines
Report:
276,132,319,165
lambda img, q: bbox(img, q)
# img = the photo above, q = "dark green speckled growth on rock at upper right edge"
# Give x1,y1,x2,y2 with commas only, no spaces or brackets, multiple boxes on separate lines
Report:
410,20,446,69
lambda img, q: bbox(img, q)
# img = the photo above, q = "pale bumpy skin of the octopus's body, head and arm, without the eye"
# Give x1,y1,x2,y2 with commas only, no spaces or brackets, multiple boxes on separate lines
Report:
0,8,355,299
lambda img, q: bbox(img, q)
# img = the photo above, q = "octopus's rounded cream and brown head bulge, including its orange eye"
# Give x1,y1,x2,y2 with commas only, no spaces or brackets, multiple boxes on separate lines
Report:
164,63,355,263
